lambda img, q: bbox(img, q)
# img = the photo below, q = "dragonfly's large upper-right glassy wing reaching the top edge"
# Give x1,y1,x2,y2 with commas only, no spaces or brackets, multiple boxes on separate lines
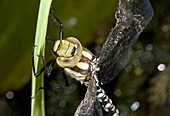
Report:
98,0,153,84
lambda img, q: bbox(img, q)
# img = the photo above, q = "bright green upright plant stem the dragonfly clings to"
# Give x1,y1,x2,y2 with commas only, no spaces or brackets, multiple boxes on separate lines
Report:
31,0,52,116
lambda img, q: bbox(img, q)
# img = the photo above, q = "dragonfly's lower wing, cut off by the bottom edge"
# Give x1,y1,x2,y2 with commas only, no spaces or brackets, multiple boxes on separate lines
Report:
74,78,103,116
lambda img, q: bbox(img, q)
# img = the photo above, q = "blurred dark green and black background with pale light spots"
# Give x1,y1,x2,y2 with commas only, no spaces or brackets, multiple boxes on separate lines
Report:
0,0,170,116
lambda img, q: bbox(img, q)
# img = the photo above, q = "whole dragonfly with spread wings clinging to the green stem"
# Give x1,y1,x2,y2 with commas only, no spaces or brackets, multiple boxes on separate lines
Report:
32,0,153,116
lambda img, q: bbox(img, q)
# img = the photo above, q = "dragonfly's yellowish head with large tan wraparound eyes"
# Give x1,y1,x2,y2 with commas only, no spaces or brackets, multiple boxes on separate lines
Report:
53,37,83,68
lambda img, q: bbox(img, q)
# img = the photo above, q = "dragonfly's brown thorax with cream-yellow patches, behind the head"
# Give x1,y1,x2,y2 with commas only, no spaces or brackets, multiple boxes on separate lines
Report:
64,48,96,85
